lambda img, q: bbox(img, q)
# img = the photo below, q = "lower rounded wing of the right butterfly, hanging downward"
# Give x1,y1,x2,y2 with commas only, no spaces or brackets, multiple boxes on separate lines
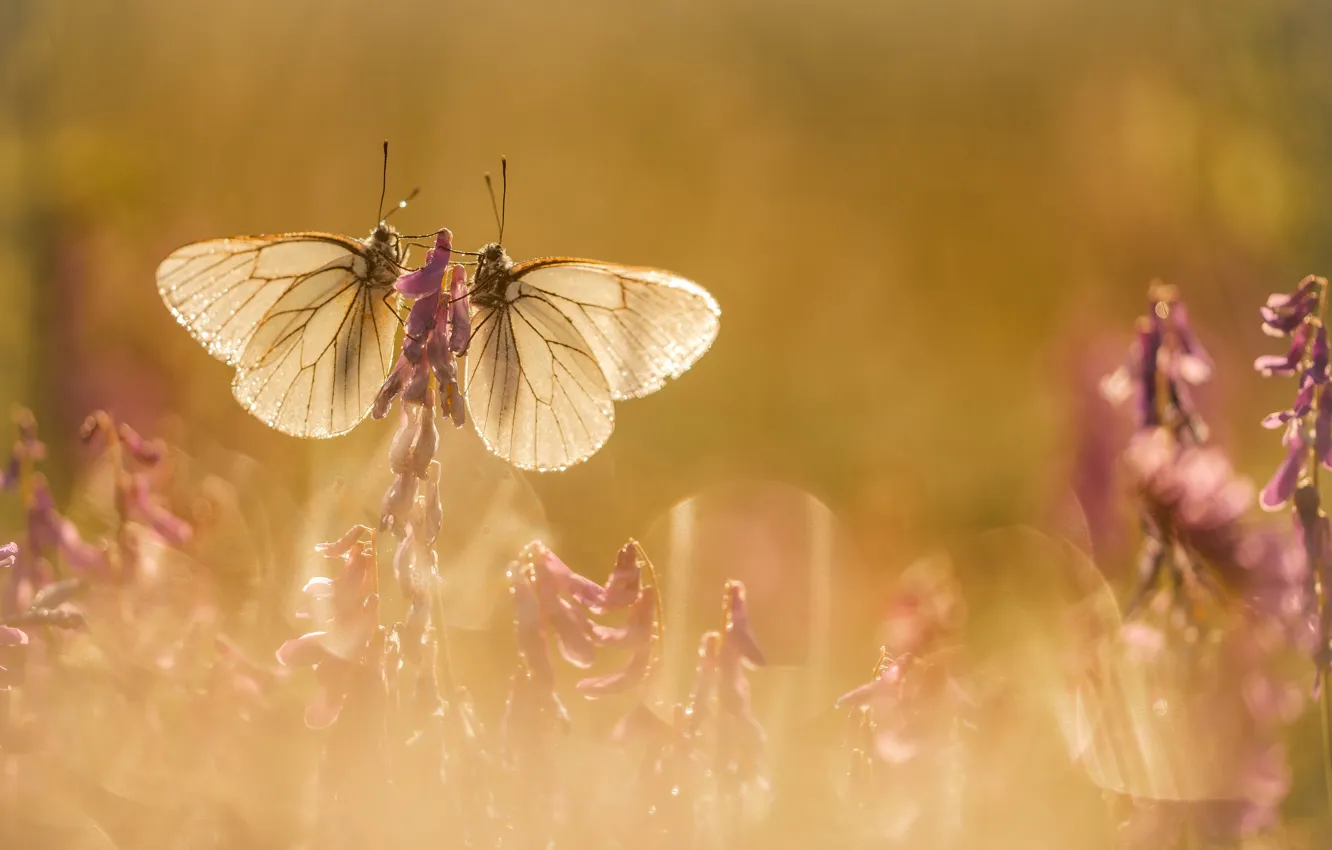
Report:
466,284,615,472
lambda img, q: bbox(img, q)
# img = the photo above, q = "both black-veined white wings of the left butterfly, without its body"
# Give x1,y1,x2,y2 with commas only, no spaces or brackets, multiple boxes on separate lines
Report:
157,233,397,438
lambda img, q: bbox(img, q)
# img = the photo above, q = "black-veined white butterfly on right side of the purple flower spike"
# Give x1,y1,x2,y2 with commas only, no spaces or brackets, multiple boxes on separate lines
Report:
464,160,722,472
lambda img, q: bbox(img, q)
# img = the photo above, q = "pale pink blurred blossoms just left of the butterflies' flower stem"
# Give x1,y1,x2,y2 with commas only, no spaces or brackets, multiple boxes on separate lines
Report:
277,526,380,729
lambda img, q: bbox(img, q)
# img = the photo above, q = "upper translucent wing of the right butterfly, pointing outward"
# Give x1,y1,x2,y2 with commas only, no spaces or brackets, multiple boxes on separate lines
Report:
514,258,722,400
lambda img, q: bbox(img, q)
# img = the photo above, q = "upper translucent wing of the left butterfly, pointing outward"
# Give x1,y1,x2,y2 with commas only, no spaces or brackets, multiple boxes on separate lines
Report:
157,233,362,365
